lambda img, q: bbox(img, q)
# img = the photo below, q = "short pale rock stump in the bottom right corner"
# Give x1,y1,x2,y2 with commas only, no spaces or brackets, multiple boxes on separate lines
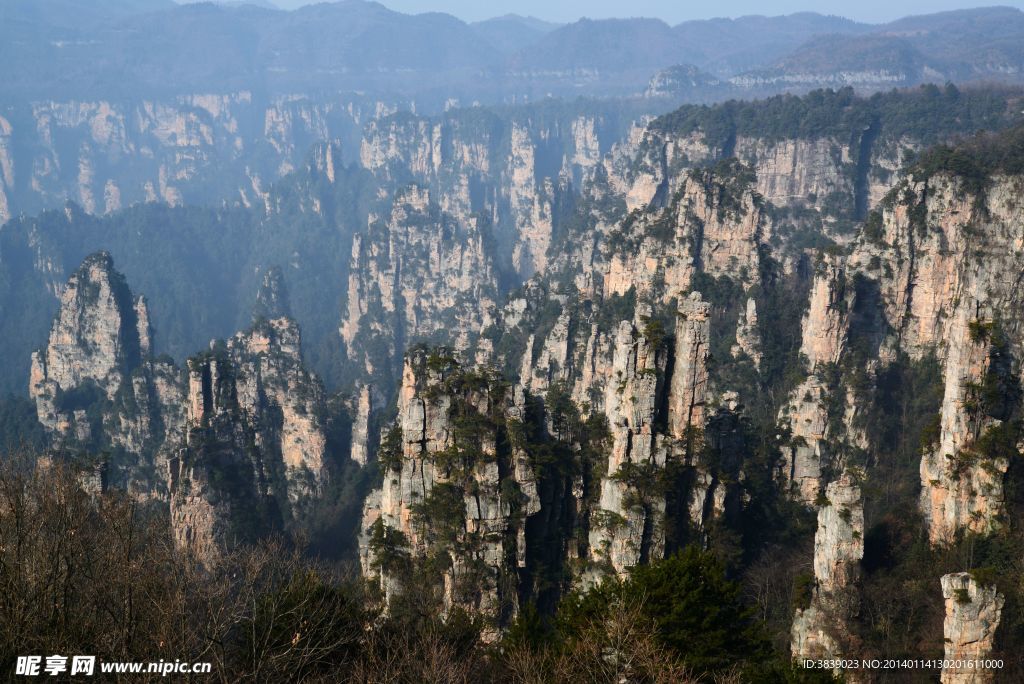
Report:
942,572,1006,684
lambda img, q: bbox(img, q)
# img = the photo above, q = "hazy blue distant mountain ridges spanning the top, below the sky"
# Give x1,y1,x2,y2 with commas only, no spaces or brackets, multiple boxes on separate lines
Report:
6,0,1024,102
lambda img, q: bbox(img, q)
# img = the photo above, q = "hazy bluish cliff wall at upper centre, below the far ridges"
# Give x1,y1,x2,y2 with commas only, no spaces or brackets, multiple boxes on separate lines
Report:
360,108,625,279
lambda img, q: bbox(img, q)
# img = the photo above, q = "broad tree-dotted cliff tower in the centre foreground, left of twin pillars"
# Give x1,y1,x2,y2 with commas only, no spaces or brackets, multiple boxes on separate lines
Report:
360,349,538,629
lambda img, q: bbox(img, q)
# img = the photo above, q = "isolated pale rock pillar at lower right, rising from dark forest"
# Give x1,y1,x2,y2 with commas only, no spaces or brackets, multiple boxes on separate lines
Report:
792,473,864,659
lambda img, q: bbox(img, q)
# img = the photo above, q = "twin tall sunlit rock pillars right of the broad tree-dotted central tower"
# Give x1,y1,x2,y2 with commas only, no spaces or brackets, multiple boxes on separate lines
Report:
590,293,725,576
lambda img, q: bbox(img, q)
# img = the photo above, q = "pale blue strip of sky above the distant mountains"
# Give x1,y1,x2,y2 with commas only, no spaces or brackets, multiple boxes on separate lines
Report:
262,0,1024,24
